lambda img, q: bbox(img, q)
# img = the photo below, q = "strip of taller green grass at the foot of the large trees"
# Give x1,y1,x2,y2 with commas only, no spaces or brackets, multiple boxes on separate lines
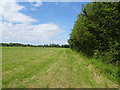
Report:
79,53,120,84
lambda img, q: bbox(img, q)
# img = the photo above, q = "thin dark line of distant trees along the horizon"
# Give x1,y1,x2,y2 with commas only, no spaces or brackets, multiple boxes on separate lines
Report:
0,43,69,48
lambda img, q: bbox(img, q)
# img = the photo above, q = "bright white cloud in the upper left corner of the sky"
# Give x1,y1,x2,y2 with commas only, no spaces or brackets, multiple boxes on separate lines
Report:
0,0,36,23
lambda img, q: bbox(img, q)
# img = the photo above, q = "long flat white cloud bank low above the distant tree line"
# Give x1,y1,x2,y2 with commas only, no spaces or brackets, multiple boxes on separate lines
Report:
2,22,66,44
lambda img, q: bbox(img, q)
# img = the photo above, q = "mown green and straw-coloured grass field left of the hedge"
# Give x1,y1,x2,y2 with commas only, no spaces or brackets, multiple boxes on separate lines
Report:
2,47,117,88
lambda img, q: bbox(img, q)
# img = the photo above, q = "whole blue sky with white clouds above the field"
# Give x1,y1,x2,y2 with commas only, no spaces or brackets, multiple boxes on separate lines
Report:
0,0,88,45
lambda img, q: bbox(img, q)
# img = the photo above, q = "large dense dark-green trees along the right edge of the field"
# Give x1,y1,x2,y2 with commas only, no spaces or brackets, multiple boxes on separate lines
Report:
68,2,120,65
